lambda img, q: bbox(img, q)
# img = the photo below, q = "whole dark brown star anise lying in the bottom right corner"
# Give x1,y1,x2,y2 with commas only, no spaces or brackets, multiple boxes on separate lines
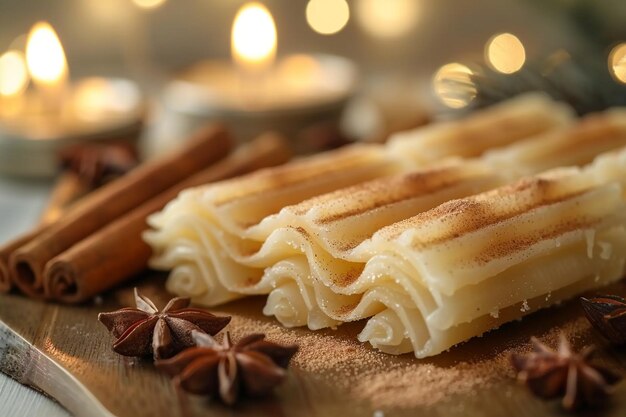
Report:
511,334,621,410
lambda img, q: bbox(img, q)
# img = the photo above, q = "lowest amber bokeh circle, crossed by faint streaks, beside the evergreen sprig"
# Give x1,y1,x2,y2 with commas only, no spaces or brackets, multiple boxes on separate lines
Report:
433,62,476,109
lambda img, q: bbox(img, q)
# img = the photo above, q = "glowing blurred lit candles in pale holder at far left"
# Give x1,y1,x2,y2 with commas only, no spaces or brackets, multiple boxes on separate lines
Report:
0,22,143,177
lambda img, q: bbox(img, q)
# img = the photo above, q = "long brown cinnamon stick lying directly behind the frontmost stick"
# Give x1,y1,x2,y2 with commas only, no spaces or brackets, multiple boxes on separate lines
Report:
8,124,233,298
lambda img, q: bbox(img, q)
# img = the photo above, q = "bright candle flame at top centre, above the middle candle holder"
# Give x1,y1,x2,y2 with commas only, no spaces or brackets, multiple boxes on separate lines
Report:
231,2,276,67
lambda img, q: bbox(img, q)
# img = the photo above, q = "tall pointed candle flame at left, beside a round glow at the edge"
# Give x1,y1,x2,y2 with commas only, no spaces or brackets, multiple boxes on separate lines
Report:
26,22,68,85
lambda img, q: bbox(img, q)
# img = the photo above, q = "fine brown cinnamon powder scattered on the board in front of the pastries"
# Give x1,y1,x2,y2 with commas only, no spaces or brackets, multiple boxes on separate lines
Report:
216,297,593,409
